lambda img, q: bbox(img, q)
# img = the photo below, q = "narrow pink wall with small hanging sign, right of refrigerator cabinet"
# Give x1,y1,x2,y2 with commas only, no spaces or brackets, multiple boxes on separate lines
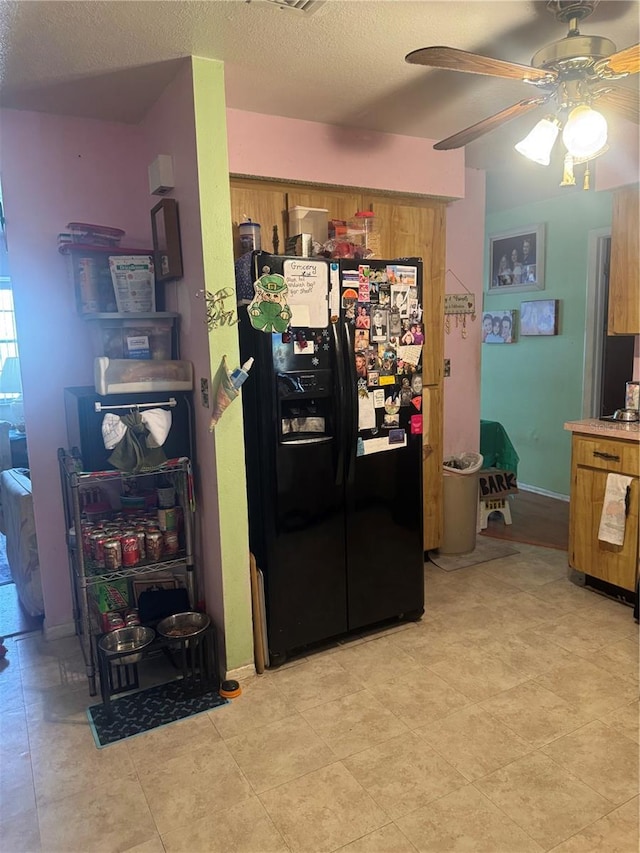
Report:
444,169,485,457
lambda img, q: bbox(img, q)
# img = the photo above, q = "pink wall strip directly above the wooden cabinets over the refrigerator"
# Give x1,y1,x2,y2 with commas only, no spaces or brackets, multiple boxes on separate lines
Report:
227,109,464,198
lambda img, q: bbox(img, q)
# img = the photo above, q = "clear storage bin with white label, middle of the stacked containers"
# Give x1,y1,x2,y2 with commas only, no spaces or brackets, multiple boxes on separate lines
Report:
85,312,178,361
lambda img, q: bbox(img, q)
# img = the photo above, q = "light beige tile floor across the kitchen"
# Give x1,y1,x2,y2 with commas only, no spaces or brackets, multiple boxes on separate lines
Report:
0,545,639,853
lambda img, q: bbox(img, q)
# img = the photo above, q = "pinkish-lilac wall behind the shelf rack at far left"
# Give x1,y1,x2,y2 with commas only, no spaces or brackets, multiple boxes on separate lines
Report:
1,110,150,628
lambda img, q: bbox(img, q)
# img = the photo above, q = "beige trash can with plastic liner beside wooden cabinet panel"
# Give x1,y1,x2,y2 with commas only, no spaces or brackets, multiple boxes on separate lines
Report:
438,453,483,554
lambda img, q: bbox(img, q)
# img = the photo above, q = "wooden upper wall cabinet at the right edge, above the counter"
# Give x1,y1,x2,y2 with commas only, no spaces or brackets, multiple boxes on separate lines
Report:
608,186,640,335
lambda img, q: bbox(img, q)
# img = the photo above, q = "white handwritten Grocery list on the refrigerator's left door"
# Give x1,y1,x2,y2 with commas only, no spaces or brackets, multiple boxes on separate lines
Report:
283,258,329,329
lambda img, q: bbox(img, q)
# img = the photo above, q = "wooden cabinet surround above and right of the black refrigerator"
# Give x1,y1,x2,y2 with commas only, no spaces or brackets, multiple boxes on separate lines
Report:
231,177,446,551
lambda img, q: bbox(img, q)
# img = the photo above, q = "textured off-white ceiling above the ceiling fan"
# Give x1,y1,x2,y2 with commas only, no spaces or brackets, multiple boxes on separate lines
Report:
0,0,640,201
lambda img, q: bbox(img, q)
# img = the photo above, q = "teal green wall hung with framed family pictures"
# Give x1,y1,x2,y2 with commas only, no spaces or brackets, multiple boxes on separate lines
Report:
478,190,612,495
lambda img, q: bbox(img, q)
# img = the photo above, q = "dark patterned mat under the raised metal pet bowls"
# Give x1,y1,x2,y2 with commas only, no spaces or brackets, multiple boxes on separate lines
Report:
87,681,228,749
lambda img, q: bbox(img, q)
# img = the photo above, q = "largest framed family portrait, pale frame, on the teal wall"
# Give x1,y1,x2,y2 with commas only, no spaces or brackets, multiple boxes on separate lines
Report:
488,223,544,293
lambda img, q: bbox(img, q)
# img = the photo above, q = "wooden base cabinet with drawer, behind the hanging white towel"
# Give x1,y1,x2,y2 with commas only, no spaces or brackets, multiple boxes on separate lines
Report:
569,433,640,590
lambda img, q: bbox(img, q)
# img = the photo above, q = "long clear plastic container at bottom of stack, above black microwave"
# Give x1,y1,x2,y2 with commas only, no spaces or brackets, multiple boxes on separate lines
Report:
93,358,193,395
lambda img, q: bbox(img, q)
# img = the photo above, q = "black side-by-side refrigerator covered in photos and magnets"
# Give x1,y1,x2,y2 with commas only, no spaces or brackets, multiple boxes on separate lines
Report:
238,252,424,665
